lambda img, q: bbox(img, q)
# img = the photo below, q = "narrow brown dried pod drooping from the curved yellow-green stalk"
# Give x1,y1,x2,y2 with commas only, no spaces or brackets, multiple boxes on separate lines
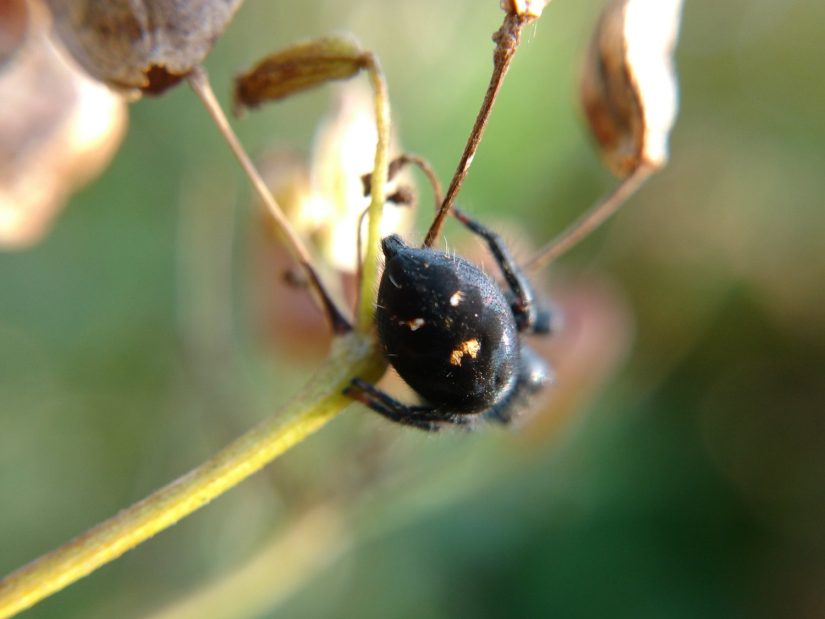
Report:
234,37,370,111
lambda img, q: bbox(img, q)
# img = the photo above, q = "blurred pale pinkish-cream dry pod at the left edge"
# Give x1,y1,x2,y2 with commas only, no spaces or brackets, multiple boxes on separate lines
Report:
0,7,126,247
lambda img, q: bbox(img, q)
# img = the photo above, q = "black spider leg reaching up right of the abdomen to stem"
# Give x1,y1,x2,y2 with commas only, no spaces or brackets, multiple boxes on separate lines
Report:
453,207,552,333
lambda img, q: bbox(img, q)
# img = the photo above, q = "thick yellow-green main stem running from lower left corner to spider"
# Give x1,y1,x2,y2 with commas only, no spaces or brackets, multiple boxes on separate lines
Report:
0,333,386,618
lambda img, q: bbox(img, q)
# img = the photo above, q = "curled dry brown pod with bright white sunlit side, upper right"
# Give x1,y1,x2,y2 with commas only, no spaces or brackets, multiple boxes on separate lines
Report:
581,0,682,177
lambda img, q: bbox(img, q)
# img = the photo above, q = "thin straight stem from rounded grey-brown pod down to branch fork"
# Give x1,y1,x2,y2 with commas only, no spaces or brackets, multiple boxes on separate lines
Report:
188,67,352,335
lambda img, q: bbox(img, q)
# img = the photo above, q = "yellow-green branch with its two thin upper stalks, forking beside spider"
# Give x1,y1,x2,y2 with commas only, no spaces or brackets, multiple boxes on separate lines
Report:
0,54,396,619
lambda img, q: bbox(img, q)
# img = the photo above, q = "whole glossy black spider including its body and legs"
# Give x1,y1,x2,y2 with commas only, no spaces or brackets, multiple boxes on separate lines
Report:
347,210,550,431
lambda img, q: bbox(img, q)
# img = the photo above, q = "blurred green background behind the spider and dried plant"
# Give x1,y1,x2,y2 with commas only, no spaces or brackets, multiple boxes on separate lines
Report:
0,0,825,618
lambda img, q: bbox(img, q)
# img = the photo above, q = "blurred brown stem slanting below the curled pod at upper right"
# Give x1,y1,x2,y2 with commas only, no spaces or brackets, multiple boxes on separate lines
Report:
523,164,655,270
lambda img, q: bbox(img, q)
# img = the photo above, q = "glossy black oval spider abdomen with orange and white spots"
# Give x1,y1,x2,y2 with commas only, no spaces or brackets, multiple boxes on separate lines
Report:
376,235,519,413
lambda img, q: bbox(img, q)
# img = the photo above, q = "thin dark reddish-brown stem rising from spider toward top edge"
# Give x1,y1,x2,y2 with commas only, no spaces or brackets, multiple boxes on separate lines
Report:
424,12,535,247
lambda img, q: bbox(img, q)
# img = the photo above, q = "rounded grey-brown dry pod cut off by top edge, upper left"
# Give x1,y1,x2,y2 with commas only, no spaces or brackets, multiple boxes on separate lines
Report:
47,0,242,94
